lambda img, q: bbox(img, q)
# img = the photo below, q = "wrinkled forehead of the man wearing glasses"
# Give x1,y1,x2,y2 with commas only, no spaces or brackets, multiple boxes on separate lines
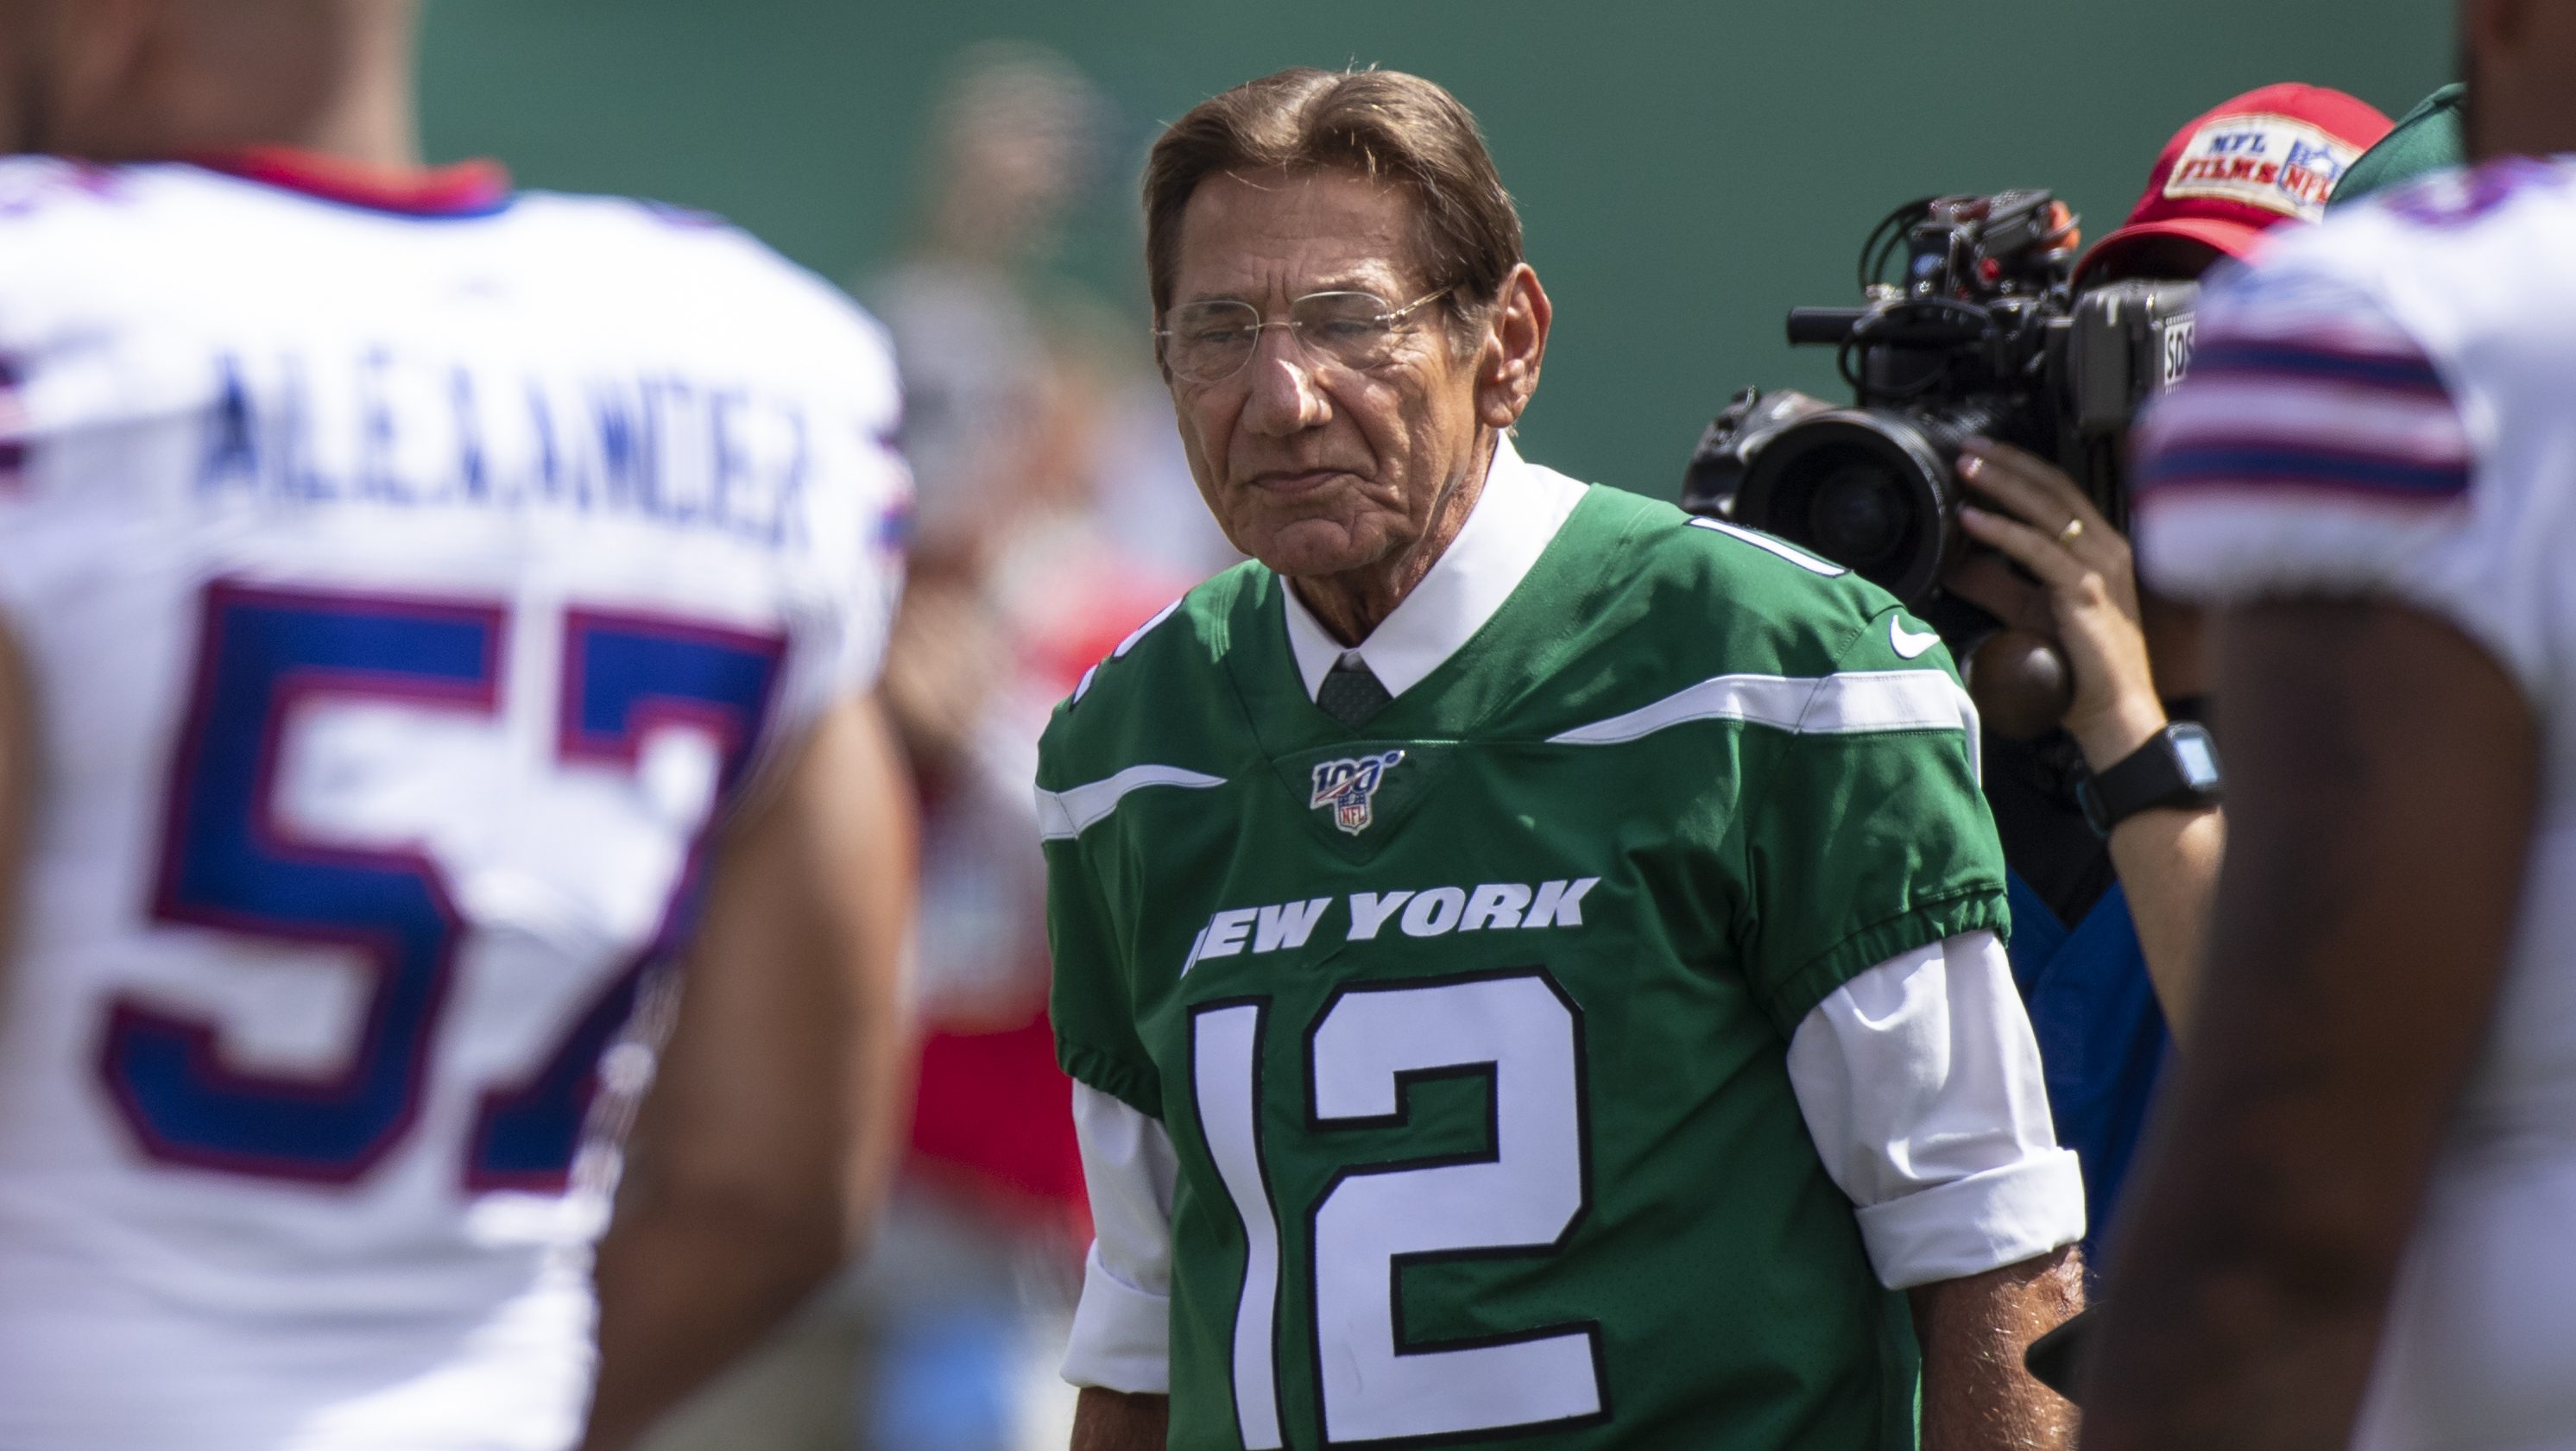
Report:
1172,167,1437,306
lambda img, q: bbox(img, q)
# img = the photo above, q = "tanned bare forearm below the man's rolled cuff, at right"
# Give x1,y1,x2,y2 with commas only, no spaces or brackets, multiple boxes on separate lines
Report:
1906,1247,2084,1451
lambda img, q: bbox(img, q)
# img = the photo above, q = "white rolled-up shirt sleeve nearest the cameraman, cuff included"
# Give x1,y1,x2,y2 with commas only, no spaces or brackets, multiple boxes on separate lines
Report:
1788,933,2084,1289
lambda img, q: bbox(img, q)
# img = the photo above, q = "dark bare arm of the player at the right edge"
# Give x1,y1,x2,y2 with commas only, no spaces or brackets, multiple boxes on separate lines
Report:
2084,603,2540,1451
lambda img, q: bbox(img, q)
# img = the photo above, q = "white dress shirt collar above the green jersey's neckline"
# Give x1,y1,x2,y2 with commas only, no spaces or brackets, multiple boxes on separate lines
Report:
1280,438,1584,698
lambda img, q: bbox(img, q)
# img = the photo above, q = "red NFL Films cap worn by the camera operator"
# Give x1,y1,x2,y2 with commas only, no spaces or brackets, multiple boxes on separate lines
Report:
2076,85,2396,281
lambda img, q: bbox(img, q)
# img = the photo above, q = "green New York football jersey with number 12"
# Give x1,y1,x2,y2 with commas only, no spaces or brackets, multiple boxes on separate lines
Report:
1039,487,2007,1451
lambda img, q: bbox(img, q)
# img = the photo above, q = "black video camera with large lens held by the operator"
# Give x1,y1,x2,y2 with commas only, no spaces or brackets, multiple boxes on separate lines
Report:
1683,191,2200,603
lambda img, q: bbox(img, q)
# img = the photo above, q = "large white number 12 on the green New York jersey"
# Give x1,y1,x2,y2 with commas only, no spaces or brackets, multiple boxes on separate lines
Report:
1190,969,1607,1451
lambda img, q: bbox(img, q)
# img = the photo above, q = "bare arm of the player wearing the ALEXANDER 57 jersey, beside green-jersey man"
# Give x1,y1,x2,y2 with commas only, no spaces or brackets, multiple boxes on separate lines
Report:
584,703,914,1451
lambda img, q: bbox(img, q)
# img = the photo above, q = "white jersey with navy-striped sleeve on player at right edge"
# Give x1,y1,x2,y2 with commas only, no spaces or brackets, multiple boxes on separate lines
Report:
2138,160,2576,1451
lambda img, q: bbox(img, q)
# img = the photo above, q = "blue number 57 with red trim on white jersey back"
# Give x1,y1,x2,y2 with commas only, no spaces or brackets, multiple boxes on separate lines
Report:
100,583,783,1190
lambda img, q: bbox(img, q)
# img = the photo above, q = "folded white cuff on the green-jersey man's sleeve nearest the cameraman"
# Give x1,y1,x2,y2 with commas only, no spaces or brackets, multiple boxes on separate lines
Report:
1857,1150,2084,1289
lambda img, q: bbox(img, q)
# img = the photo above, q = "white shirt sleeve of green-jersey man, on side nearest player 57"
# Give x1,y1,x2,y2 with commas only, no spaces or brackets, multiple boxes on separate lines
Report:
1064,1082,1180,1394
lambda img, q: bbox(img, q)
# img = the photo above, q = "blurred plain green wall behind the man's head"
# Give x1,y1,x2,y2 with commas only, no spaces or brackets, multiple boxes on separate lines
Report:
425,0,2450,495
